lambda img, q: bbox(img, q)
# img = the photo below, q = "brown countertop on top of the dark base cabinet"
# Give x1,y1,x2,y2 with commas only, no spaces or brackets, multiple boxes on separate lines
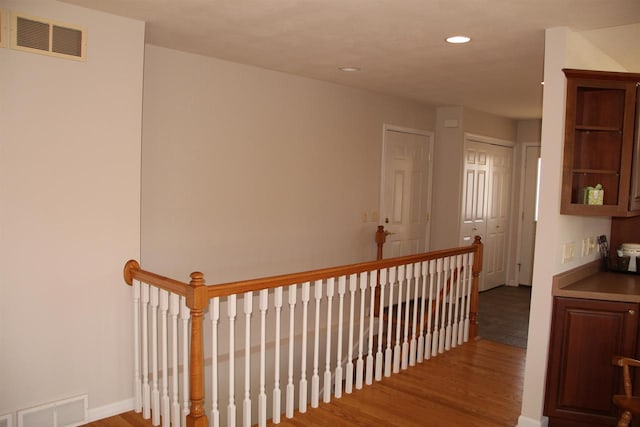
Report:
553,263,640,303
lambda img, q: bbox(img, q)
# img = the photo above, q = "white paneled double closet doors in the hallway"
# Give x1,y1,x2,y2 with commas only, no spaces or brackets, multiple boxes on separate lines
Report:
460,134,513,291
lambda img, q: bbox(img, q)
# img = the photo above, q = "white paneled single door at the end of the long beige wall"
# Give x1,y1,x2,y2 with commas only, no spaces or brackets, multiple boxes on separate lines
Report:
380,128,433,258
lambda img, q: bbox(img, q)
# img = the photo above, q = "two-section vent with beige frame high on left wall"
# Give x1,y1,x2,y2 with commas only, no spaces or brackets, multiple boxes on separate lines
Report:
11,14,86,61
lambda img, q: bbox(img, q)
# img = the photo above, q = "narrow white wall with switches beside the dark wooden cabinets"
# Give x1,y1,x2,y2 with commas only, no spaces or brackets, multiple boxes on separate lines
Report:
518,28,626,427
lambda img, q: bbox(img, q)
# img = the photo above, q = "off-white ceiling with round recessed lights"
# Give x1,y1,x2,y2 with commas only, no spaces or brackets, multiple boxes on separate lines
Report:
64,0,640,119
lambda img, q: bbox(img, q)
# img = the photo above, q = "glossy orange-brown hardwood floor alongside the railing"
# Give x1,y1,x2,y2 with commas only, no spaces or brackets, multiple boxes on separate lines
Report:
87,340,525,427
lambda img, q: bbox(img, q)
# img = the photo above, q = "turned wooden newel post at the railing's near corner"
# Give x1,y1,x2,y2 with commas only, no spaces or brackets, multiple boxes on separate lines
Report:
187,272,209,427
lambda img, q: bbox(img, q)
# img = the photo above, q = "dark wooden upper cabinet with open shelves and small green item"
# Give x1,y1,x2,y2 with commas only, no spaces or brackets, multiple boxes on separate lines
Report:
560,69,640,217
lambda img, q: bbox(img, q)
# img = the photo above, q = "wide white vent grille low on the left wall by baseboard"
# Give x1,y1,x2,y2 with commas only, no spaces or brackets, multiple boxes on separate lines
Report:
18,394,88,427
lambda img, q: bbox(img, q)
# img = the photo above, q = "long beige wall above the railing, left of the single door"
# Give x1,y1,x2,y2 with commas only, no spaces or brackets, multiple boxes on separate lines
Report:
142,46,435,283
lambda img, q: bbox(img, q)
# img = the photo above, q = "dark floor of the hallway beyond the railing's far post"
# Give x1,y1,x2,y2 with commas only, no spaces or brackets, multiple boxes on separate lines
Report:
478,286,531,348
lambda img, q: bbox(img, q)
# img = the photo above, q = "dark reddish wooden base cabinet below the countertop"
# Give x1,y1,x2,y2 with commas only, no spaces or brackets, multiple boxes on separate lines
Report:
545,297,640,427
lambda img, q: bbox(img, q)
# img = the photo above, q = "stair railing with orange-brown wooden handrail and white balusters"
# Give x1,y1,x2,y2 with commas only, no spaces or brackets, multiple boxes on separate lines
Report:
124,237,482,427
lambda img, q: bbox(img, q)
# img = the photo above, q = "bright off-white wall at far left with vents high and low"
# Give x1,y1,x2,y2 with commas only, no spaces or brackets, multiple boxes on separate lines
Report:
0,0,144,422
